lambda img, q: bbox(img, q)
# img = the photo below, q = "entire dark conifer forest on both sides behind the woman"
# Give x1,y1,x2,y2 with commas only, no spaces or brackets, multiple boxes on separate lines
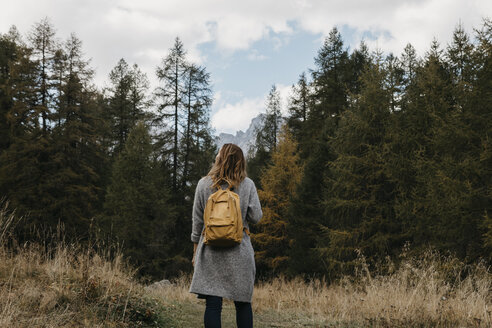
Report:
0,18,492,281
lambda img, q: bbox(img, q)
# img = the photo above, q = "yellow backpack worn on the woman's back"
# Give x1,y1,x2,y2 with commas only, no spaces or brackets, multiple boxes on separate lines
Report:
203,181,249,247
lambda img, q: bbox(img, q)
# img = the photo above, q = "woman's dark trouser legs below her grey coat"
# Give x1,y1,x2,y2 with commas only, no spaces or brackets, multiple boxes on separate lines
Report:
203,295,253,328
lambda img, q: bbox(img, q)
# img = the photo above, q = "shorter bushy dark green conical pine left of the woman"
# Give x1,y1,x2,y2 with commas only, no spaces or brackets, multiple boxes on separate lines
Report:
101,123,175,277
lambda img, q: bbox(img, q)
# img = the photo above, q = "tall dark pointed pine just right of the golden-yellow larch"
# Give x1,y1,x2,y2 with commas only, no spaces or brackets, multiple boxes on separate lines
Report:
288,27,357,274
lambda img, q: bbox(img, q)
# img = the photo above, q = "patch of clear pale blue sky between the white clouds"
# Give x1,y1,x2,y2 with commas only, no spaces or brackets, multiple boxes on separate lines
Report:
198,20,321,100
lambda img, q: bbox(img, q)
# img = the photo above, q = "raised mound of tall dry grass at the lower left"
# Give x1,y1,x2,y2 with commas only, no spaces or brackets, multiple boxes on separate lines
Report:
0,204,177,327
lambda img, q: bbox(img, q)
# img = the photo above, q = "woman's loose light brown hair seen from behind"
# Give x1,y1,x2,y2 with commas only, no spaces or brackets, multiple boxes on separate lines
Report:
207,143,246,188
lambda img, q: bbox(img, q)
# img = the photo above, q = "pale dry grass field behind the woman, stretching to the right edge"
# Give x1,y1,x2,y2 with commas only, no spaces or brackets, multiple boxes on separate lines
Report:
155,251,492,327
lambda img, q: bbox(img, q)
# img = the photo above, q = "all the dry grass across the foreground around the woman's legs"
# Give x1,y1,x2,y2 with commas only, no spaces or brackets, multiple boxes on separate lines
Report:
0,200,492,328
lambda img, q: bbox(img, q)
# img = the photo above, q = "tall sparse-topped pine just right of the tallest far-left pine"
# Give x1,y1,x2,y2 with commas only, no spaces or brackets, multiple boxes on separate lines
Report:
40,33,106,238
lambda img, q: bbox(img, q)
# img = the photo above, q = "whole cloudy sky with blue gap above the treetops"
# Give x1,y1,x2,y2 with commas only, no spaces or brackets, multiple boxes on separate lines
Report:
0,0,492,134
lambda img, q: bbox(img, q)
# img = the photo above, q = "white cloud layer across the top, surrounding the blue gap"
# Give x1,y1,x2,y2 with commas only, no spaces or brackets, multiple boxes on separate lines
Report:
0,0,492,91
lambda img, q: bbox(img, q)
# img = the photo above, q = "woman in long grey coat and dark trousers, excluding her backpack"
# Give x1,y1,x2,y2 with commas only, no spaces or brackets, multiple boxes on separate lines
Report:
190,143,263,328
